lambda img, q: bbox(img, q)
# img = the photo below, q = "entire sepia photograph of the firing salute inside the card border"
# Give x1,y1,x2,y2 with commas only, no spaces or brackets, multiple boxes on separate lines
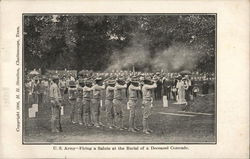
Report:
22,13,217,144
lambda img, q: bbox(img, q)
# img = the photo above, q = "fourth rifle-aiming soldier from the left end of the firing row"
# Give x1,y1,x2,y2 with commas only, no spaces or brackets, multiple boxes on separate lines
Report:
91,77,105,128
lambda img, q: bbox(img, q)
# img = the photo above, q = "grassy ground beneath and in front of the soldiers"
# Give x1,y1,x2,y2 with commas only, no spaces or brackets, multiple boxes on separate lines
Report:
24,94,216,144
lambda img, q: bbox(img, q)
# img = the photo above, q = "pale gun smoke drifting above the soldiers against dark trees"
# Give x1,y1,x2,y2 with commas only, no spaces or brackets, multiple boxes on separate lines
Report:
107,35,204,72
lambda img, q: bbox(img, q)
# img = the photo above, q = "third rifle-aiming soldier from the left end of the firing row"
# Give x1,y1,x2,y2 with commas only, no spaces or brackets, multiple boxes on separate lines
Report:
82,78,93,126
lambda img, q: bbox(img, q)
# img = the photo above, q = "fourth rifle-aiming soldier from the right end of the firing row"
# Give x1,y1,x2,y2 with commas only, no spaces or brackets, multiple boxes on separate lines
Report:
105,80,115,129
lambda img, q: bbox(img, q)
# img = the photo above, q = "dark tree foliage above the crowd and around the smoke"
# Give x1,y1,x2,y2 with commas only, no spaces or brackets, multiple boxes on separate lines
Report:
24,14,215,72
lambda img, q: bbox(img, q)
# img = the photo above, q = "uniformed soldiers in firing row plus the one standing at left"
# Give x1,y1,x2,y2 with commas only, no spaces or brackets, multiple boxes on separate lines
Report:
50,75,157,134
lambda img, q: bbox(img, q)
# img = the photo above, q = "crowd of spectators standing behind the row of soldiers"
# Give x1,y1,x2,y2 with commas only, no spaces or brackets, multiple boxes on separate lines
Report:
25,70,215,108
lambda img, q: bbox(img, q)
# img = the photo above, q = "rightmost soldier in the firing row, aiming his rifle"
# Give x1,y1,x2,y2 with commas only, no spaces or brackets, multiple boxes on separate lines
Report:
142,77,157,134
